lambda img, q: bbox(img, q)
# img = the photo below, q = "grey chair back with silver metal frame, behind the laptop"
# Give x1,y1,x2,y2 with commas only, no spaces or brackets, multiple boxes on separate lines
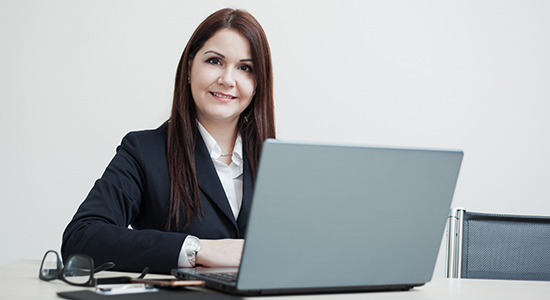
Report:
446,208,550,281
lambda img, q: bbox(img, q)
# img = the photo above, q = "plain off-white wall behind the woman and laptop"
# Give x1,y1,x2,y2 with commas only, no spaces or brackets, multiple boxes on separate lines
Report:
0,0,550,277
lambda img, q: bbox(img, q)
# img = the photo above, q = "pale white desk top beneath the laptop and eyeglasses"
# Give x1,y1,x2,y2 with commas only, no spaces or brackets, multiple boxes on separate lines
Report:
0,260,550,300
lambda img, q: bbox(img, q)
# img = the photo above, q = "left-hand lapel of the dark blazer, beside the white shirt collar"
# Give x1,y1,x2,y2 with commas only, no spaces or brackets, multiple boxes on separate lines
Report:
195,134,236,227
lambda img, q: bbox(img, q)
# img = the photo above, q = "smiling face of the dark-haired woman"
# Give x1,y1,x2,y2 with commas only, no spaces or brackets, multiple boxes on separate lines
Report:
189,29,256,126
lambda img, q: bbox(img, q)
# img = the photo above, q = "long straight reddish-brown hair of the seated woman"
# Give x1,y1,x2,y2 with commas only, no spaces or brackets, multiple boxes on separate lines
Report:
166,8,275,231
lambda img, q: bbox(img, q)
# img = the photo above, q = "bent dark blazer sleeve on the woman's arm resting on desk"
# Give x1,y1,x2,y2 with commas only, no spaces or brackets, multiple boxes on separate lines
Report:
61,130,187,273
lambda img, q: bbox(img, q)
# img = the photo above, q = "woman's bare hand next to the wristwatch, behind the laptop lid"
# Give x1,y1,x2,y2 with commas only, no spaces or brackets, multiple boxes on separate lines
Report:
196,239,244,267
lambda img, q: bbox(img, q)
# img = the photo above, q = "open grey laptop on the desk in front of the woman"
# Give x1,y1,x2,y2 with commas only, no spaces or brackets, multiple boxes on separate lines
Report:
172,140,463,295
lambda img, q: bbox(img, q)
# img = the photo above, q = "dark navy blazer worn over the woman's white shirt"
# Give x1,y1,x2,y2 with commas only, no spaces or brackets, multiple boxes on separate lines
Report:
61,125,253,273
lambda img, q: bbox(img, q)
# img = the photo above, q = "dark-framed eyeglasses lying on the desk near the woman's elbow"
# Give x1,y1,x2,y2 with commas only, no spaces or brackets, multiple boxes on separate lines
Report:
38,250,149,287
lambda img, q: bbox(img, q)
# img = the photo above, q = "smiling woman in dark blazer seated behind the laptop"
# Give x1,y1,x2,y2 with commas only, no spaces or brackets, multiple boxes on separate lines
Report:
61,9,275,273
